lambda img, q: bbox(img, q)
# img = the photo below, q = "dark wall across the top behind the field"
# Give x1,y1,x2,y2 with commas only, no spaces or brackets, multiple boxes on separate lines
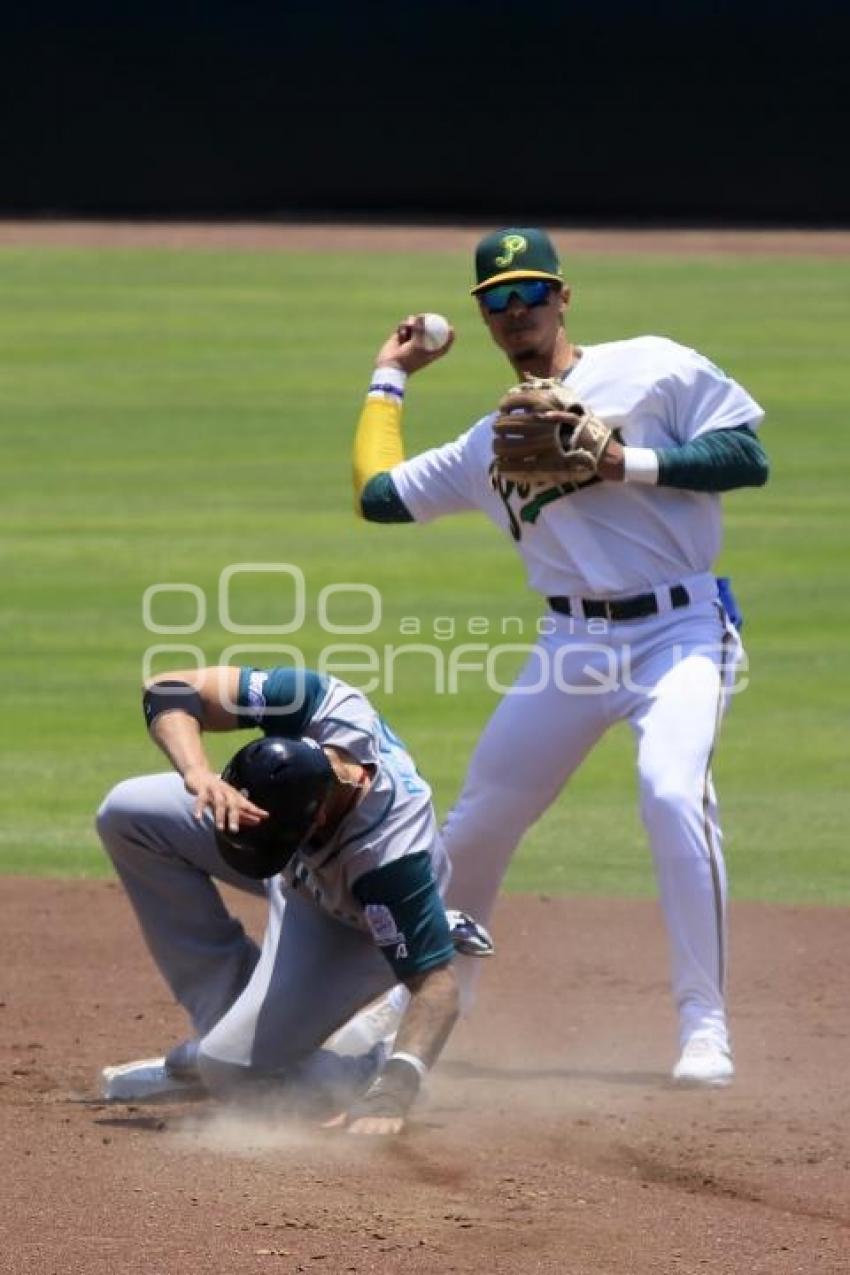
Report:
0,0,850,224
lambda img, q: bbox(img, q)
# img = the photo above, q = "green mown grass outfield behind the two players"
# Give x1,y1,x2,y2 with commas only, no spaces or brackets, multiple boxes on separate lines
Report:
0,244,850,904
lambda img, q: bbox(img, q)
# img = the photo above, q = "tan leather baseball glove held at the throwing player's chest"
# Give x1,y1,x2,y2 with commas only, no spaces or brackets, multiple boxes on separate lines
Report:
493,376,614,487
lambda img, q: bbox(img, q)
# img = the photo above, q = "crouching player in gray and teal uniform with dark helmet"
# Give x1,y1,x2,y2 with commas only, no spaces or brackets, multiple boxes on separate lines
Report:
98,667,488,1135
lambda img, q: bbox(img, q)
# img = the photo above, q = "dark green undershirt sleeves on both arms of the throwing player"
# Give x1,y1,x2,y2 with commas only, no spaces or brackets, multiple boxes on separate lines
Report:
361,425,770,523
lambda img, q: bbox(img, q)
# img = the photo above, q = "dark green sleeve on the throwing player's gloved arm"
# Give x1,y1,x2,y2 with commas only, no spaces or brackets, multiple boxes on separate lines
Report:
656,425,770,491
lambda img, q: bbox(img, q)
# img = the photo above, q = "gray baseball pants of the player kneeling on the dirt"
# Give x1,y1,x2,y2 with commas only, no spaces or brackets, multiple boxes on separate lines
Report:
97,773,395,1091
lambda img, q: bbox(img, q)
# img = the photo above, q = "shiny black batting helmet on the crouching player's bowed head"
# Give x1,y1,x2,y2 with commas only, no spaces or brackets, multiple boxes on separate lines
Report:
215,736,336,880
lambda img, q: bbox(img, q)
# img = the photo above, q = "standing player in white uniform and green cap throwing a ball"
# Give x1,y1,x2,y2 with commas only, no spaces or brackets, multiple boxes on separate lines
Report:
354,228,767,1085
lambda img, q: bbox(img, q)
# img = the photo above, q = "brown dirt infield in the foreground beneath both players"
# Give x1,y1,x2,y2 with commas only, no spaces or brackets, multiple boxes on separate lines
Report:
0,878,850,1275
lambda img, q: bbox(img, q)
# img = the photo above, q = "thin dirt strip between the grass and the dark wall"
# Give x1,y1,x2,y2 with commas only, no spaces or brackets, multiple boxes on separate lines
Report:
0,221,850,256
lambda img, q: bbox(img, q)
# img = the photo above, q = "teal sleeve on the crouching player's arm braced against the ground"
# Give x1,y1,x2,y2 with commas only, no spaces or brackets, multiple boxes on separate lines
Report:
352,850,455,982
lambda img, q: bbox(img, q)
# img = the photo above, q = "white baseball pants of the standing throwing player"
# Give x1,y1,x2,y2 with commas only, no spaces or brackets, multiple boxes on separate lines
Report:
442,581,742,1043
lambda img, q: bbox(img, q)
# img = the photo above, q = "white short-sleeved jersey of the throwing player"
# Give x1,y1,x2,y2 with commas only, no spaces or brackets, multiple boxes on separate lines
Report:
391,337,765,598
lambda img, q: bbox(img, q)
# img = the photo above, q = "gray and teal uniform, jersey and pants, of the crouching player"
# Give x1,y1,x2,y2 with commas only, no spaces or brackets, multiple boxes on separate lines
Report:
98,668,454,1089
